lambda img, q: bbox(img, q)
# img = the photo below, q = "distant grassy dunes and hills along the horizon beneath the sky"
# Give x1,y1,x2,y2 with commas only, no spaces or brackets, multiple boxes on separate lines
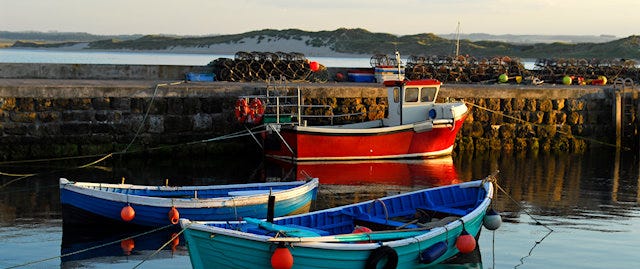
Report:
6,28,640,59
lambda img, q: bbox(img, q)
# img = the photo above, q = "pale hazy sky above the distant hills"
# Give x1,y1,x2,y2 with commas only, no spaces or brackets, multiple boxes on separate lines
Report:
0,0,640,38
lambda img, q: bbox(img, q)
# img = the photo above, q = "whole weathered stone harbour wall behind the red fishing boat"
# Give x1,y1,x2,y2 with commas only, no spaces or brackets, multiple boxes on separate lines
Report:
0,63,615,160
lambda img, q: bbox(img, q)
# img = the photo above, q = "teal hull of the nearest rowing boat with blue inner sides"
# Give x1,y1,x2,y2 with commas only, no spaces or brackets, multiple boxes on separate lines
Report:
181,182,493,269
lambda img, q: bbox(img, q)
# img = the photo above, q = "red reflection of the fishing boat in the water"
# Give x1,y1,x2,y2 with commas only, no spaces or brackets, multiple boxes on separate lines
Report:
265,156,461,210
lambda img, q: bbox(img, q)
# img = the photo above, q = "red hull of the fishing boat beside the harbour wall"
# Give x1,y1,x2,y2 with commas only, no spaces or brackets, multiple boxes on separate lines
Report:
265,115,466,161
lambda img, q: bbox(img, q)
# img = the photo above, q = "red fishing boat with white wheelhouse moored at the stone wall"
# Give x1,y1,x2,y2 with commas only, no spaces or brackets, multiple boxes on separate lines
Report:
264,79,468,162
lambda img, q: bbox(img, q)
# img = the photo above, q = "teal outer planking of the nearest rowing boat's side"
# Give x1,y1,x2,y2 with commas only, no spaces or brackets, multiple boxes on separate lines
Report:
184,219,482,269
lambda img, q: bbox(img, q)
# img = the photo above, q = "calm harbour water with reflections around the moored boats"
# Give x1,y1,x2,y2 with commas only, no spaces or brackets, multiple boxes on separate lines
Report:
0,151,640,268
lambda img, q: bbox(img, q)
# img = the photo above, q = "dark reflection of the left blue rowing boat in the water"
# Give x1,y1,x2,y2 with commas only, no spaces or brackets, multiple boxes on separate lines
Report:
60,225,189,268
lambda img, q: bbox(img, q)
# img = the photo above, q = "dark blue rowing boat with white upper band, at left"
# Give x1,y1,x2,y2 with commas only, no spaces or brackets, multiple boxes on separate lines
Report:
60,178,318,227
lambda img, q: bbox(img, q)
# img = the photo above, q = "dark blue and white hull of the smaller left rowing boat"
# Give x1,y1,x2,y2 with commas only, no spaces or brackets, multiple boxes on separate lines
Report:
60,179,318,227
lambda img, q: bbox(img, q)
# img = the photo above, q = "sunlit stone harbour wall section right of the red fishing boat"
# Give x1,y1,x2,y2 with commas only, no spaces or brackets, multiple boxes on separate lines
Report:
441,85,615,152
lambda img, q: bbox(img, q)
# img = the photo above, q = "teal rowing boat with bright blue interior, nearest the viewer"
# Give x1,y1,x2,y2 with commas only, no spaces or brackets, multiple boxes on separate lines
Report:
180,176,499,269
